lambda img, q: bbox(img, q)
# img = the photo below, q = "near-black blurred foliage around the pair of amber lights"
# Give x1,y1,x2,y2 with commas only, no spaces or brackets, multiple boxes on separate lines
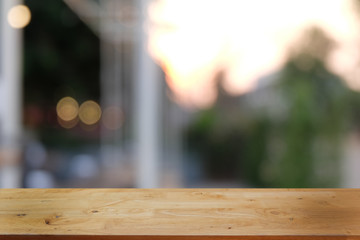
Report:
23,0,100,148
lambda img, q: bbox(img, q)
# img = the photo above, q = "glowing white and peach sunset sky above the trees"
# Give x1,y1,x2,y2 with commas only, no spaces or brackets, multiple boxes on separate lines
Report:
149,0,360,107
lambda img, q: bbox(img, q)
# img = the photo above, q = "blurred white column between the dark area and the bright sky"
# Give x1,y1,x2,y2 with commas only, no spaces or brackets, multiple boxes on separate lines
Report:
134,0,161,188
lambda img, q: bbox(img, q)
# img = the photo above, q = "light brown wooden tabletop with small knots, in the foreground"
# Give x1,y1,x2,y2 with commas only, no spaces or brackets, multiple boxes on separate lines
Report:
0,189,360,240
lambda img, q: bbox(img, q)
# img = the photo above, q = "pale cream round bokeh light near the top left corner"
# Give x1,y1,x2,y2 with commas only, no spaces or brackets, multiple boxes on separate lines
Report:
7,5,31,28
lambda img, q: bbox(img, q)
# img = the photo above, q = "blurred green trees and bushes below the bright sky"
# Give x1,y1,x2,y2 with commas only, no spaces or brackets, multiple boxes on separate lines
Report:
185,26,360,188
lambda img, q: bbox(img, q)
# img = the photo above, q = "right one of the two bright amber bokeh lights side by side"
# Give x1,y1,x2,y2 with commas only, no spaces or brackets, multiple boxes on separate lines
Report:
79,100,101,125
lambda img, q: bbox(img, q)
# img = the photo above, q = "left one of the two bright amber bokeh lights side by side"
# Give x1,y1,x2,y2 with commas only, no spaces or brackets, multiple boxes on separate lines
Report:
56,97,79,122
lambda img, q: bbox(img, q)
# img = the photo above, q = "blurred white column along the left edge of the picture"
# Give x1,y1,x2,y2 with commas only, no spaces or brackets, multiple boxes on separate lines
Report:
0,0,22,188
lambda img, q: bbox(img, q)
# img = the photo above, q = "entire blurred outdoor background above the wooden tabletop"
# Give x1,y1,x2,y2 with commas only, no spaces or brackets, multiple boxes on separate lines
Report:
0,0,360,188
